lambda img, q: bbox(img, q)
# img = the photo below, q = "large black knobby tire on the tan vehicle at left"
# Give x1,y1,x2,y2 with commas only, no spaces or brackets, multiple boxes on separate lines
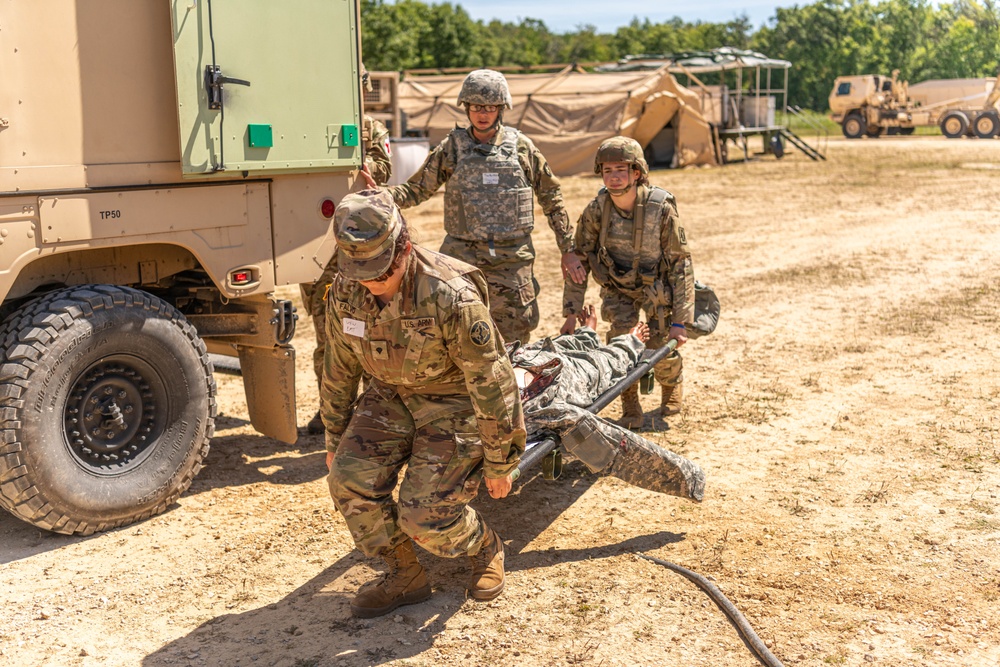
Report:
0,285,216,535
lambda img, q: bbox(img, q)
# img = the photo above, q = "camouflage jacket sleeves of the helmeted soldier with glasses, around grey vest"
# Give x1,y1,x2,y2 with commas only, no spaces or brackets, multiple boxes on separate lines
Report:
388,125,573,253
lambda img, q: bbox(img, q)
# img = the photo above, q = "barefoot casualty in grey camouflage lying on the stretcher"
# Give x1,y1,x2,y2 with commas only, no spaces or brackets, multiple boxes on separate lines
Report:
510,306,705,502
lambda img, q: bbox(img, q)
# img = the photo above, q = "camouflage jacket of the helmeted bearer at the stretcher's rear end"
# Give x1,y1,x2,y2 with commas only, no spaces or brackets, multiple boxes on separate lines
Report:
563,186,694,324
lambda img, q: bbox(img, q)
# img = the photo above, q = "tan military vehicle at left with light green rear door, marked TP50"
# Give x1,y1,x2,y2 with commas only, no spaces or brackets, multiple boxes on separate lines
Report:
0,0,362,535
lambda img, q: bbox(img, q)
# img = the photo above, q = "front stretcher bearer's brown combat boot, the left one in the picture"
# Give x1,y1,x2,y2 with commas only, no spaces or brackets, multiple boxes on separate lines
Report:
351,538,431,618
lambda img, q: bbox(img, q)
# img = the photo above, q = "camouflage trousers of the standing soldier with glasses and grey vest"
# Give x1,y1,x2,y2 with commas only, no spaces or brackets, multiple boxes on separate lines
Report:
440,235,539,343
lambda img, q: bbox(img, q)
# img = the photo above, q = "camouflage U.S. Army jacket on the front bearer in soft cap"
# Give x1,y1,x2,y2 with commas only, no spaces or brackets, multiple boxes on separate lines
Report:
320,245,525,478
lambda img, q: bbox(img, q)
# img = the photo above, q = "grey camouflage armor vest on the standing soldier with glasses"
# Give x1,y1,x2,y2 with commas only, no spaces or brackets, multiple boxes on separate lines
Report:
444,127,535,241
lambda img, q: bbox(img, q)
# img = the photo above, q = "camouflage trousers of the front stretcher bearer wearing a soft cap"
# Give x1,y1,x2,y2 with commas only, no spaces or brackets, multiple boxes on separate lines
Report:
327,389,484,558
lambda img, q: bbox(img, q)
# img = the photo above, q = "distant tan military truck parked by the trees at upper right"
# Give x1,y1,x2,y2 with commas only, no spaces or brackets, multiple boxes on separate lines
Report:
829,70,1000,139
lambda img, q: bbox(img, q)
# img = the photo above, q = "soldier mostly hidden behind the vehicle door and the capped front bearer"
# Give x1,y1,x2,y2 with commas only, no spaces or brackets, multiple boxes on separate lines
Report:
299,64,392,435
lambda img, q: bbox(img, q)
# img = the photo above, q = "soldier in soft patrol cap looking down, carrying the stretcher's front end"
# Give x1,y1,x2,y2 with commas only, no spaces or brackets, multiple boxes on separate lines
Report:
320,190,525,618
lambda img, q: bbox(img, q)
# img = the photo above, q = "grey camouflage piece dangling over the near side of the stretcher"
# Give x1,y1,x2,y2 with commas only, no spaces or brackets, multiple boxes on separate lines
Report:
524,400,705,502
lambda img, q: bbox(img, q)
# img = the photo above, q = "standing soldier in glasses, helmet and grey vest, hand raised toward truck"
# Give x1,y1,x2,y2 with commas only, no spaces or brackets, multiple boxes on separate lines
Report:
380,69,585,342
